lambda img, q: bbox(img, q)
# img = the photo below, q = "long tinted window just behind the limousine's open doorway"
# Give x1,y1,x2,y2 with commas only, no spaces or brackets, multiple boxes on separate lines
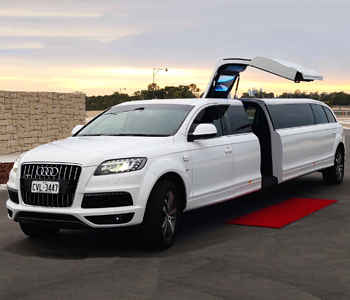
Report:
267,103,316,129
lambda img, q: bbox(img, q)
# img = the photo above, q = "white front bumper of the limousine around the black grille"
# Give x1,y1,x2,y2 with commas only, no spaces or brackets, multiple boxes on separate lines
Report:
6,167,156,228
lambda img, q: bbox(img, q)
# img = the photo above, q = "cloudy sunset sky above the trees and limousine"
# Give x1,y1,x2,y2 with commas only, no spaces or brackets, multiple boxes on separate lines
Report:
0,0,350,96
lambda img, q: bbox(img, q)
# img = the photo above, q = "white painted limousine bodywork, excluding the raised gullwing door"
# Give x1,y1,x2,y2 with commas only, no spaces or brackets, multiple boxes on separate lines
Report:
7,99,343,227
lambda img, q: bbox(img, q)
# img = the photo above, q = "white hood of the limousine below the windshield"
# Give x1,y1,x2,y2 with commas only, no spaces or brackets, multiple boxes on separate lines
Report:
20,136,174,167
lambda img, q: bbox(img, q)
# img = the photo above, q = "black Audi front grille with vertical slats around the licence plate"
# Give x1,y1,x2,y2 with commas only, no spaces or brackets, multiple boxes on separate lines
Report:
21,164,81,207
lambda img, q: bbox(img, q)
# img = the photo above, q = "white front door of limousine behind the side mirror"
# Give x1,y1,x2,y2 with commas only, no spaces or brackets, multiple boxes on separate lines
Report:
187,106,234,209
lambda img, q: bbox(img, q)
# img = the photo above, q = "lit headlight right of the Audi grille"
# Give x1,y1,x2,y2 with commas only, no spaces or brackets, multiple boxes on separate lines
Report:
94,157,147,176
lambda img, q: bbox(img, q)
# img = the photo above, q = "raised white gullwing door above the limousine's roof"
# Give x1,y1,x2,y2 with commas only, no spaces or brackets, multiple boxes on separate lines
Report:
203,56,323,98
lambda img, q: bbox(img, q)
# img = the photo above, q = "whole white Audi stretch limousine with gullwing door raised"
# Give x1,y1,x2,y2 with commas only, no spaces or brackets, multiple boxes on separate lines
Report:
6,57,345,249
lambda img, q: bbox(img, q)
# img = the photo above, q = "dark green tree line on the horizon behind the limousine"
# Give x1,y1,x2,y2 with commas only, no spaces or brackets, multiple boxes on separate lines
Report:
85,83,350,111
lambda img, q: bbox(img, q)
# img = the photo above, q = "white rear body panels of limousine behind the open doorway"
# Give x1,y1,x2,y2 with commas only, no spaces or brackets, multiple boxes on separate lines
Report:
264,99,345,182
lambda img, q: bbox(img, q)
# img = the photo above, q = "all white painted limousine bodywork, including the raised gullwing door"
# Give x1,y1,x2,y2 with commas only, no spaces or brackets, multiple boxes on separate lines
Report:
6,57,345,248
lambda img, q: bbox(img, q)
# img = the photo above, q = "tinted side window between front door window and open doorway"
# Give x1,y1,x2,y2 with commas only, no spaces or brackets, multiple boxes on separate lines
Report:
220,106,252,135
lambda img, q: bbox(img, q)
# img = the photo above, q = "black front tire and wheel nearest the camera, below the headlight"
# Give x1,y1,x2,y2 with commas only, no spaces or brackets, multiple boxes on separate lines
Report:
141,180,180,250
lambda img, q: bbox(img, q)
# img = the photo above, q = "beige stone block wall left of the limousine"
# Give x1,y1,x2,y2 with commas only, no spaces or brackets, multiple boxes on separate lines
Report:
0,91,85,155
